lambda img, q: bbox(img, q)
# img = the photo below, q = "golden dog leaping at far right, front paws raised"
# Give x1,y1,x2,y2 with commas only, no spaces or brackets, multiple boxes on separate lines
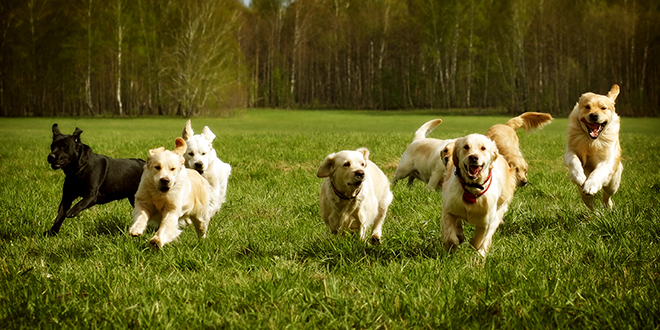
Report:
564,84,623,209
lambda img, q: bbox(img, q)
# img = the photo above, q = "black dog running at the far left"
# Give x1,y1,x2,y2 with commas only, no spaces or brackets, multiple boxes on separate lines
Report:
44,124,144,236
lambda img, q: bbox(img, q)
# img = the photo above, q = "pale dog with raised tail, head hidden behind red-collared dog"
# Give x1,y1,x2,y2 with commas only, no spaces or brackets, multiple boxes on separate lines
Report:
392,119,456,190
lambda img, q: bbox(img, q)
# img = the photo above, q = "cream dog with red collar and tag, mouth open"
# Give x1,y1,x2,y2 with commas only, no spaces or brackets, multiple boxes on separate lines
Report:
442,134,516,256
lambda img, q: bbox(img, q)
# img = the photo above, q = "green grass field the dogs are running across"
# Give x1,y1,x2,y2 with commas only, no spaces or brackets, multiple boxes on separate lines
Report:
0,110,660,329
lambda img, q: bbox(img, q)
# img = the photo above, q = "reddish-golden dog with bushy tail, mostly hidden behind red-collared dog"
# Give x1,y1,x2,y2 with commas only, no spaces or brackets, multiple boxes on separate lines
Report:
486,112,552,187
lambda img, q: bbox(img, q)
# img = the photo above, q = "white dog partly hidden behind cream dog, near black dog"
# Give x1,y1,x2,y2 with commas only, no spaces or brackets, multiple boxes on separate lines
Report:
181,119,231,216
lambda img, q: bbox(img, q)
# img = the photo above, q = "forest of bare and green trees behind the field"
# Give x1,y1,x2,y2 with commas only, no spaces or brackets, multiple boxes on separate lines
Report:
0,0,660,116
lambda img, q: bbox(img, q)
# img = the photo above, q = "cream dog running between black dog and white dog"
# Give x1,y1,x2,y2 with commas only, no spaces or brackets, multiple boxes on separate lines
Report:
129,138,211,248
